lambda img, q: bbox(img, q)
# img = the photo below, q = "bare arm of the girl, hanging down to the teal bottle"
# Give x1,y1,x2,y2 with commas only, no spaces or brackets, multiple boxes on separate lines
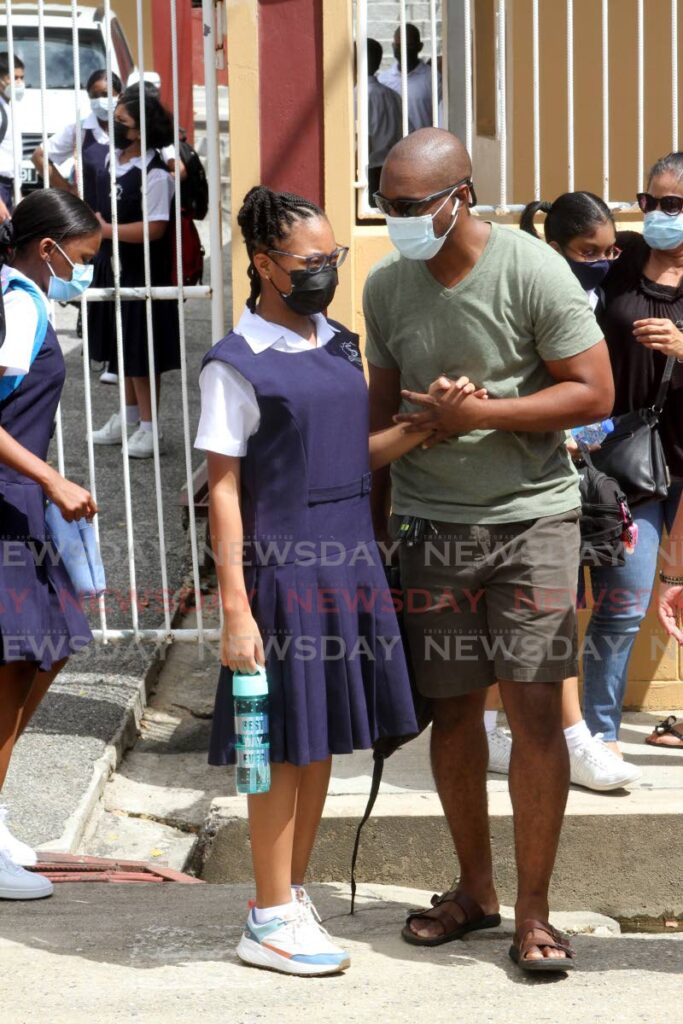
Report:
207,452,265,672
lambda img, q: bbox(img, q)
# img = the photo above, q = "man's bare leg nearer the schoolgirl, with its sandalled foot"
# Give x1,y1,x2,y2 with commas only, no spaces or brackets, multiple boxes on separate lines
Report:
410,689,499,938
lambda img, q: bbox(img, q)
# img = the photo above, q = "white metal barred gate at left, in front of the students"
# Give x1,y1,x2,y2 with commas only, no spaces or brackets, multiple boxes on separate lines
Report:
4,0,225,643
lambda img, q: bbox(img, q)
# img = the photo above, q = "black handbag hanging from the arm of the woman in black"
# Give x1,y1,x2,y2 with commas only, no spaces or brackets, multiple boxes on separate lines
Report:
591,355,676,509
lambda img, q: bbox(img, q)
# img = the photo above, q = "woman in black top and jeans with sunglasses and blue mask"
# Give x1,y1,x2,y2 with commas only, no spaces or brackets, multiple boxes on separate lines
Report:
584,153,683,752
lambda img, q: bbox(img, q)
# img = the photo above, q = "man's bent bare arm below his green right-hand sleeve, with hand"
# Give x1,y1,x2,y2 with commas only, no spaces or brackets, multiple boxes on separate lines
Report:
394,340,614,443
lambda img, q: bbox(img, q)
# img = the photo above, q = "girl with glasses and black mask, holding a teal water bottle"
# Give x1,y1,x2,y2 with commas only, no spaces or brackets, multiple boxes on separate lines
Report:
196,186,466,974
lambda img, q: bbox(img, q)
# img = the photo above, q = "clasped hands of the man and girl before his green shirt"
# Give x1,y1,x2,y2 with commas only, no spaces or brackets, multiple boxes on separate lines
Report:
393,376,488,447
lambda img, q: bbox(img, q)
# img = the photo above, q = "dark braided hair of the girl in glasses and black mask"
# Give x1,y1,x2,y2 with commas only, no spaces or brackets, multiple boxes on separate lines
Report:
238,185,325,312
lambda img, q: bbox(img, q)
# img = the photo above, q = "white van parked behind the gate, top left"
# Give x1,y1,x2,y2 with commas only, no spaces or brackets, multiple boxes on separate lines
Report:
0,3,159,188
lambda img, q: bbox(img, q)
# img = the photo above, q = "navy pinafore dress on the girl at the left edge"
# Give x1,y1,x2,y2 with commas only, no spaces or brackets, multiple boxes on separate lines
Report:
0,284,92,671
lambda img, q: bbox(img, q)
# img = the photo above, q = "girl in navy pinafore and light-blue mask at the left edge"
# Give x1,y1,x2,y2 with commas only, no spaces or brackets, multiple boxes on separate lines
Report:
0,188,100,899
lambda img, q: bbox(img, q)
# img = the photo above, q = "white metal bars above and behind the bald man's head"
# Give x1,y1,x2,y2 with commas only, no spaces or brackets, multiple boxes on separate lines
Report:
354,0,682,219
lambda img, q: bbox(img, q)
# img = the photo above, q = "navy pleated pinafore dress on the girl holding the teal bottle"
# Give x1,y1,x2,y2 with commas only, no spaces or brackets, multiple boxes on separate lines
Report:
204,325,417,765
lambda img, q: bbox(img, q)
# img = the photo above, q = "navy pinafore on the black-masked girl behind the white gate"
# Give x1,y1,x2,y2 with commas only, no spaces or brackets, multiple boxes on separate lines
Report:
88,147,180,377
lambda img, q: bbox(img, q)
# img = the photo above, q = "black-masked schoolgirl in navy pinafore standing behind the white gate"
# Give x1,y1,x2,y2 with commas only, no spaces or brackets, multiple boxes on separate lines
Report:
88,86,180,459
